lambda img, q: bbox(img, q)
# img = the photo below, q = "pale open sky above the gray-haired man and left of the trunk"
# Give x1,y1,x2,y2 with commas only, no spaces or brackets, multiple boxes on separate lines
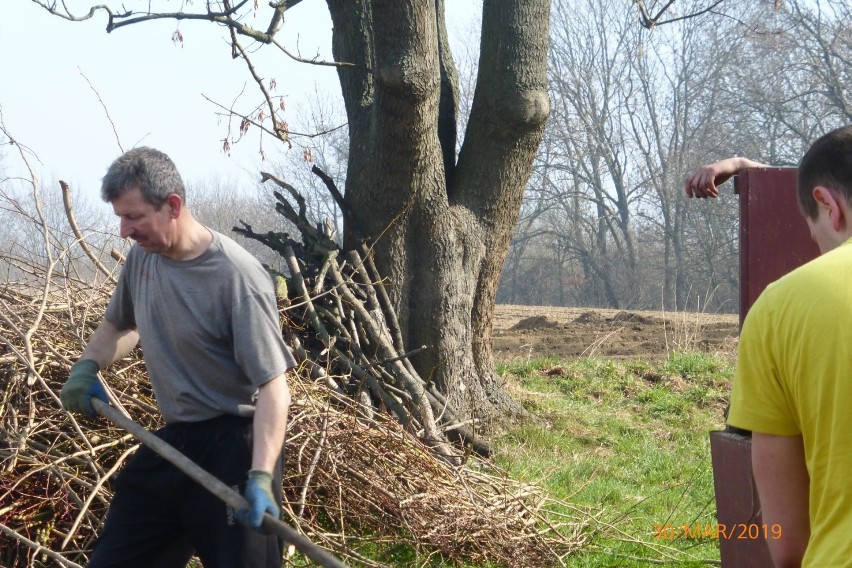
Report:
0,0,482,212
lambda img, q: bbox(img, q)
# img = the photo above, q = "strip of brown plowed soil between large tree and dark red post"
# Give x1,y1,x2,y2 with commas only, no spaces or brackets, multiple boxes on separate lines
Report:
493,304,739,361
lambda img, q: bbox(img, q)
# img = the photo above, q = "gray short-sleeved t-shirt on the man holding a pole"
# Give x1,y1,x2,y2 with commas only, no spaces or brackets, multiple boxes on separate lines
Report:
104,231,296,423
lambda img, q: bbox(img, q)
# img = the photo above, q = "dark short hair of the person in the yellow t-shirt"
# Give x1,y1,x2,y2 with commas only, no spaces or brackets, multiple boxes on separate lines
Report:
797,126,852,219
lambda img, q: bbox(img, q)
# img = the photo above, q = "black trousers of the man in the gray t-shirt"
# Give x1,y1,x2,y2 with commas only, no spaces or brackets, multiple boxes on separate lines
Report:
89,415,284,568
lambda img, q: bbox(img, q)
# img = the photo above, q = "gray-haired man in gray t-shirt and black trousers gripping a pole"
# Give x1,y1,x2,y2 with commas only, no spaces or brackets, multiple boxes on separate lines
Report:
61,148,295,568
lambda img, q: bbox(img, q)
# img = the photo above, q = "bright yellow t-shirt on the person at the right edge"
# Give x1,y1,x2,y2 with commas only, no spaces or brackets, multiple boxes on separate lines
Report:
728,239,852,567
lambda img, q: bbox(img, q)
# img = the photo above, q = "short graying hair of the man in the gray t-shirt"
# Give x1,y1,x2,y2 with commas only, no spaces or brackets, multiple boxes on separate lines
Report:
101,146,186,208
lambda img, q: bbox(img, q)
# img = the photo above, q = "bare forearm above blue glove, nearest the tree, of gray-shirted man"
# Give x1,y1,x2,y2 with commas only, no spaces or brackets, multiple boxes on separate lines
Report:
251,374,290,472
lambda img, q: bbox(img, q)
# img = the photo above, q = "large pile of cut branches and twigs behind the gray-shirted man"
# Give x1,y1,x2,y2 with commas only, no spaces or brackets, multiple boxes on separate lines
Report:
0,175,586,567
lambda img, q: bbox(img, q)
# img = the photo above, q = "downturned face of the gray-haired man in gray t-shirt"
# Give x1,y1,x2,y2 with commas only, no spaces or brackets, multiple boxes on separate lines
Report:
112,187,176,256
